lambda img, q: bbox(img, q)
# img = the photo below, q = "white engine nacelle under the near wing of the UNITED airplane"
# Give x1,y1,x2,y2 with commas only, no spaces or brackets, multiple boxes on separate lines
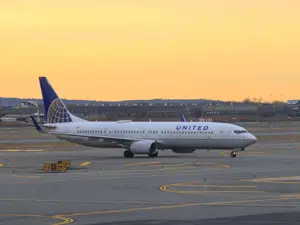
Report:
129,140,157,155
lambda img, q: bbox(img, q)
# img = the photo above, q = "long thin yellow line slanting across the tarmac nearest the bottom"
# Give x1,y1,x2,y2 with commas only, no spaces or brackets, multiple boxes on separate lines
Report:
61,197,293,217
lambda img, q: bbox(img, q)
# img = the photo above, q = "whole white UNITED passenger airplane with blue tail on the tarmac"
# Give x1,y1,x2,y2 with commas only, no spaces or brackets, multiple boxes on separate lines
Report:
33,77,256,158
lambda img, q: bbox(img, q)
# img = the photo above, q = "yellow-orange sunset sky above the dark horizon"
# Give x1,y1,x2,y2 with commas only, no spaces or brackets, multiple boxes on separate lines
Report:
0,0,300,101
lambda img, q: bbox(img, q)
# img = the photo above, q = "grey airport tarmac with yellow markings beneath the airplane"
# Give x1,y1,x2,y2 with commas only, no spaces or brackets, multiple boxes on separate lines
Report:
0,123,300,225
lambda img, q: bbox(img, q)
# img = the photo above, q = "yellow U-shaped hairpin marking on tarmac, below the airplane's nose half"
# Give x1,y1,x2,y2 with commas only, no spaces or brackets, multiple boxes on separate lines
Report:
159,183,264,195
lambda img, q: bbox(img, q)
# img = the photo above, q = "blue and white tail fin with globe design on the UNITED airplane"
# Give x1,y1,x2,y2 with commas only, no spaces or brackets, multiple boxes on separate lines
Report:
39,77,86,123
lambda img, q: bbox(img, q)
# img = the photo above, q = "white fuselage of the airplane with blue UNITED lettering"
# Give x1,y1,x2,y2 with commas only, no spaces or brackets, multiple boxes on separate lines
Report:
45,122,256,149
